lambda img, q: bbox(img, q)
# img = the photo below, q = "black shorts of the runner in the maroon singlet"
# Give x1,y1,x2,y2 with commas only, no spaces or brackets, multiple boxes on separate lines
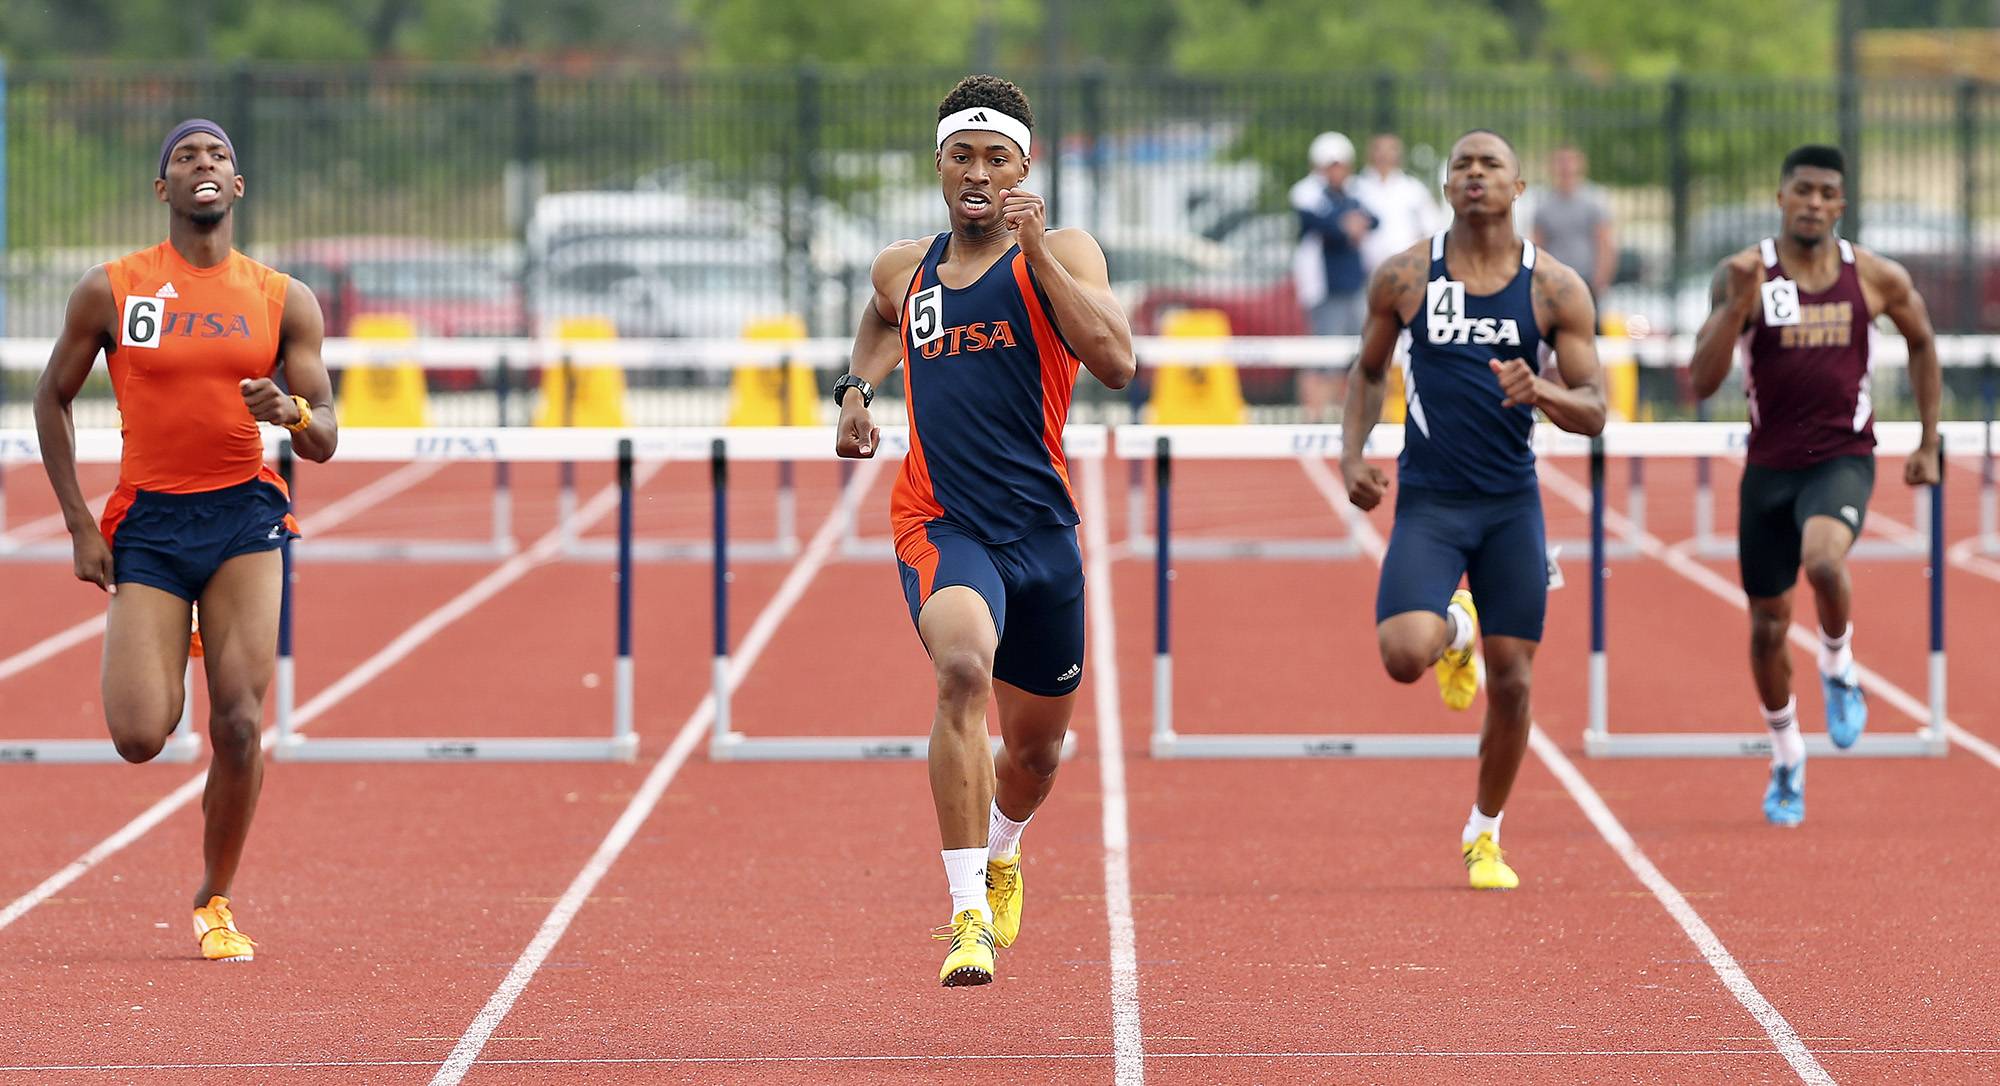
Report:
1736,456,1874,600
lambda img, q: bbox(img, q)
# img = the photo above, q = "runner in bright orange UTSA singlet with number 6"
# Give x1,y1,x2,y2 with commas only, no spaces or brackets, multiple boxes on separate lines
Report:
34,120,338,962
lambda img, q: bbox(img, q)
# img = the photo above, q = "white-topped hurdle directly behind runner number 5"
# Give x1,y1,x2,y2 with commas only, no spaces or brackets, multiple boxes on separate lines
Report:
704,426,1110,762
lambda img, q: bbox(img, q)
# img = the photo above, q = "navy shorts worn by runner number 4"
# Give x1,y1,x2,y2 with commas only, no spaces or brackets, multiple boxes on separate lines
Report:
1376,486,1548,642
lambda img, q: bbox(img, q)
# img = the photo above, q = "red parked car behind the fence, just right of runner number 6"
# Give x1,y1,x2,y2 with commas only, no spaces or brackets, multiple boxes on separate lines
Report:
266,234,524,336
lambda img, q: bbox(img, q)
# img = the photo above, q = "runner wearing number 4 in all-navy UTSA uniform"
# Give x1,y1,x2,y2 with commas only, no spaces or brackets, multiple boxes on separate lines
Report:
1340,128,1604,890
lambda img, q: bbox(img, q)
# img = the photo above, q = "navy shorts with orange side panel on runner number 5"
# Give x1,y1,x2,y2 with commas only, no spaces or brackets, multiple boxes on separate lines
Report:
896,520,1084,698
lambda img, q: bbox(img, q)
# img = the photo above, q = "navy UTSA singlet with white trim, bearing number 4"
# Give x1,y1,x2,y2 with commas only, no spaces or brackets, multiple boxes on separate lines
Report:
1396,232,1546,494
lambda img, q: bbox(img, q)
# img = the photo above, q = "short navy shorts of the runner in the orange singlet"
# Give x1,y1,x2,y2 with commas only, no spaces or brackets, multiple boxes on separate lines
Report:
112,478,298,602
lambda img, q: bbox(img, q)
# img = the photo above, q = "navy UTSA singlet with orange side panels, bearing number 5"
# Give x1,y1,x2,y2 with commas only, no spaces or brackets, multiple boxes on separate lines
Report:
890,234,1078,550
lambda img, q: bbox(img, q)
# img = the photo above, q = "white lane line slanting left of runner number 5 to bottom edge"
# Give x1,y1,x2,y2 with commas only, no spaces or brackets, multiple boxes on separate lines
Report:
430,460,884,1086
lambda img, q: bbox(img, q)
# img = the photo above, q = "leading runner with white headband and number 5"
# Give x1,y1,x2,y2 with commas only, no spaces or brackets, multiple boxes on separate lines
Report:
834,76,1136,986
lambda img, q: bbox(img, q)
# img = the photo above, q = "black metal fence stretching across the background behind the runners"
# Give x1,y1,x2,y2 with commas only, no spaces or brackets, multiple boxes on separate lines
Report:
0,66,2000,418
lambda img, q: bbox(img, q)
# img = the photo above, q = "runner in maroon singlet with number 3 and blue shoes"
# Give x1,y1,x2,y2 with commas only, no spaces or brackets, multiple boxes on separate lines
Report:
1688,144,1942,826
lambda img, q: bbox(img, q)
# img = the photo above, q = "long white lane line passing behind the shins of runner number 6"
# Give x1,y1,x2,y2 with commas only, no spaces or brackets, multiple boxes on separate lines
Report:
0,466,658,930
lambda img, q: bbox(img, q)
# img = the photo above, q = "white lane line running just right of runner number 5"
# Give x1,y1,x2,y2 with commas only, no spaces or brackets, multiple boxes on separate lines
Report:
1084,458,1146,1086
